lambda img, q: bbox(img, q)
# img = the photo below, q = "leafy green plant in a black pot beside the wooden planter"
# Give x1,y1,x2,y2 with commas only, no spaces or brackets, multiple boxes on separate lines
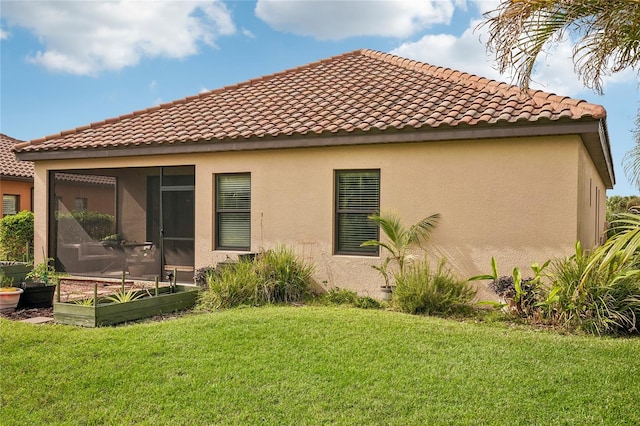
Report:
18,258,60,308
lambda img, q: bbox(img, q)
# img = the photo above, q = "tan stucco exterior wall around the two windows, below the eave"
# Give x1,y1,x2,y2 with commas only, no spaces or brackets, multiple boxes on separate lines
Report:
36,136,604,296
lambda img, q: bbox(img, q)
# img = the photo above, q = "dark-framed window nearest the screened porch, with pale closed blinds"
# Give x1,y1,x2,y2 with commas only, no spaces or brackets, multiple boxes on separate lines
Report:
216,173,251,250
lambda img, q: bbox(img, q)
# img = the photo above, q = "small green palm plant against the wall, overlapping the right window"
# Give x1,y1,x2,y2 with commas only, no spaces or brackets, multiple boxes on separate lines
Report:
361,212,440,287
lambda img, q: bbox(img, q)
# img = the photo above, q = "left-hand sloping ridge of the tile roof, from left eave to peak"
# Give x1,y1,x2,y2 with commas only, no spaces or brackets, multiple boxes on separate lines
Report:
28,49,364,148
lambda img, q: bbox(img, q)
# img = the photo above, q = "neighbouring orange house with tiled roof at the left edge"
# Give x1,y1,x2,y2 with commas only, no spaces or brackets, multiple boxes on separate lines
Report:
0,133,33,217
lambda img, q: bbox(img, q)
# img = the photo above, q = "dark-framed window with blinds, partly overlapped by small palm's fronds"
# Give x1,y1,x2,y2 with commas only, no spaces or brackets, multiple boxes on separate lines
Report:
335,170,380,256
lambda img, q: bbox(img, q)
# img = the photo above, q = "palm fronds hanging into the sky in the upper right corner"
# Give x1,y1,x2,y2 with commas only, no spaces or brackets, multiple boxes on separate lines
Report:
481,0,640,93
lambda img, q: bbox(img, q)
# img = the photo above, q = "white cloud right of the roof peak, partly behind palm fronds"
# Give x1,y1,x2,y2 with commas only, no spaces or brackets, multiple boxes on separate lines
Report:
391,16,634,96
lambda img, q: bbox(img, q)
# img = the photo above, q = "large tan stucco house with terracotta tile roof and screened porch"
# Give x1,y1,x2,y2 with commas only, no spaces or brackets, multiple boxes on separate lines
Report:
15,50,615,296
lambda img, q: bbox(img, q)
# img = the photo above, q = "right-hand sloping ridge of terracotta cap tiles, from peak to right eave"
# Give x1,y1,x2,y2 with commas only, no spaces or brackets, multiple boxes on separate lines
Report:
352,49,607,119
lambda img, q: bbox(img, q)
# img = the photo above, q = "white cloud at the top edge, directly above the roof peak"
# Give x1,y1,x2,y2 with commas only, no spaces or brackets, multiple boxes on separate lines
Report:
255,0,461,40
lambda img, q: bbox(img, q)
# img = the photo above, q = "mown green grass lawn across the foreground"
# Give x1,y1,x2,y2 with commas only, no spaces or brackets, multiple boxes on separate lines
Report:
0,307,640,425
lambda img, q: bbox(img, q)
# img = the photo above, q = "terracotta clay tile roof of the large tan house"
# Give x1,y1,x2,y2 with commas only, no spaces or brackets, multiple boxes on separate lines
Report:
16,50,606,152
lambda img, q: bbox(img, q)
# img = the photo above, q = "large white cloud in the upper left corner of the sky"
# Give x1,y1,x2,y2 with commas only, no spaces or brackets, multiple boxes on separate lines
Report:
2,0,235,74
